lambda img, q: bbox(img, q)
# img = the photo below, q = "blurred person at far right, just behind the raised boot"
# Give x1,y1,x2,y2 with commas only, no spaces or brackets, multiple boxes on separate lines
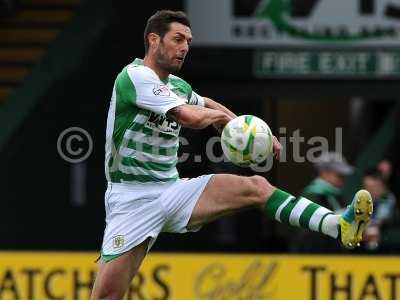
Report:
362,168,397,250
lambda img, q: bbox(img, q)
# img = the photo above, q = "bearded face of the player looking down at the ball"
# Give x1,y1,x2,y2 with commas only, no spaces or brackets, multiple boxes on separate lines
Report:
154,22,192,73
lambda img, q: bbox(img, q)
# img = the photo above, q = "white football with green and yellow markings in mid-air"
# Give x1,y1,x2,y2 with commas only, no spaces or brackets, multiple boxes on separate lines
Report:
221,115,273,166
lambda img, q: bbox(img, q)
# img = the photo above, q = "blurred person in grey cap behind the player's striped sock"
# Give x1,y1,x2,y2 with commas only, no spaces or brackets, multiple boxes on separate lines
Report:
289,152,353,253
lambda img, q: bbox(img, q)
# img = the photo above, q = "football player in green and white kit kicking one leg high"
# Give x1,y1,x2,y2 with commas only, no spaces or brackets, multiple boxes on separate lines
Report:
91,10,372,300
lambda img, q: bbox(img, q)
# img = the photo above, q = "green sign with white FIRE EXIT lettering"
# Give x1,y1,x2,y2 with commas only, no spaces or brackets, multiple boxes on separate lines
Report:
253,50,400,78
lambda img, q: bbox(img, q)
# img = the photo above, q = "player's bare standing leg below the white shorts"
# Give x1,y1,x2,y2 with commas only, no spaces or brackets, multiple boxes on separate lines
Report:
90,239,149,300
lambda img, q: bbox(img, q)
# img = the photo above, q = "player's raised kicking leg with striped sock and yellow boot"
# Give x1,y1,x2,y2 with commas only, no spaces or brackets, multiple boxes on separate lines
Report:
188,174,372,248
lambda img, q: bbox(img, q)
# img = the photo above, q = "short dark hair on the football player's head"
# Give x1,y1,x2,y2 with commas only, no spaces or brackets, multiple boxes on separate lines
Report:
144,10,191,53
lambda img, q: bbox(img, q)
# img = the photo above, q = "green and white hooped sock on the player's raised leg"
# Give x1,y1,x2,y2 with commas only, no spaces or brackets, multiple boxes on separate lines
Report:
265,189,340,238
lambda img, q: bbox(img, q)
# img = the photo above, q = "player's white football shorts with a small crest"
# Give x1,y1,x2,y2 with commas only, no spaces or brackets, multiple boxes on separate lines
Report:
102,174,212,257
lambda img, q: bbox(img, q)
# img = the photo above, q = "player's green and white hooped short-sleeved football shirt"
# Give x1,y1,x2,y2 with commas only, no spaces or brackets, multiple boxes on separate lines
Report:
105,59,204,183
